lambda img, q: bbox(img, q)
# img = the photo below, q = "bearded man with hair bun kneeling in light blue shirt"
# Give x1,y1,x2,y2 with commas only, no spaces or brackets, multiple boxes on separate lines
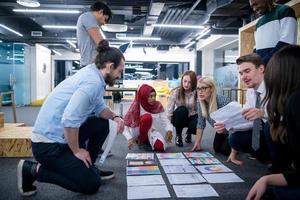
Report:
18,40,125,196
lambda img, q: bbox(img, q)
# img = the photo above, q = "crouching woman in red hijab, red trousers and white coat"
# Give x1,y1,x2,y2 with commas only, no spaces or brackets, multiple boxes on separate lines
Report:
123,84,173,151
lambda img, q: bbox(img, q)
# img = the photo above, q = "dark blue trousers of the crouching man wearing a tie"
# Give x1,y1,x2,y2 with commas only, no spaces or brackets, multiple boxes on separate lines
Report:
229,120,270,162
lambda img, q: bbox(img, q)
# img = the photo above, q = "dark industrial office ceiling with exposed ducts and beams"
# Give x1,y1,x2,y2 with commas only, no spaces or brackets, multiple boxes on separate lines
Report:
0,0,290,48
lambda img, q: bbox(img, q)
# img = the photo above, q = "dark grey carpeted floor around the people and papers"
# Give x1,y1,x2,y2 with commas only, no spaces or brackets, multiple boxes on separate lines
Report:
0,107,268,200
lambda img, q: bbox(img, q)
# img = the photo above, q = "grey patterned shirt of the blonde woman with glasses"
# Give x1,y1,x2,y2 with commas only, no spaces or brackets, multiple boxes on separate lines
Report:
197,95,230,129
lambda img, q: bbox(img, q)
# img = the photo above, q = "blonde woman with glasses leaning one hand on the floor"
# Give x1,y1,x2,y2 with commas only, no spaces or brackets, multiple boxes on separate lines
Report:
192,77,231,155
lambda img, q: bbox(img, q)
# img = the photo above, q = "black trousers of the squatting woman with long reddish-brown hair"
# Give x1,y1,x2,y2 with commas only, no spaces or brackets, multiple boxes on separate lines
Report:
171,106,198,137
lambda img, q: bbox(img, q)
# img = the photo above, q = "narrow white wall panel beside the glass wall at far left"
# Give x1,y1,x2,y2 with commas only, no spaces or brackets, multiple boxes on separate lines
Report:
30,44,52,102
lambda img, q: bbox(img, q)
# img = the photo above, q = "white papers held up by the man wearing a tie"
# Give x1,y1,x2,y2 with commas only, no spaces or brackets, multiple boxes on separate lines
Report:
210,101,253,132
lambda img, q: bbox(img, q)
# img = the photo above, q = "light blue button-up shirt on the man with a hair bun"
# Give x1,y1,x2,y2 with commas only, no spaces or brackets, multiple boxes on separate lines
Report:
33,64,107,143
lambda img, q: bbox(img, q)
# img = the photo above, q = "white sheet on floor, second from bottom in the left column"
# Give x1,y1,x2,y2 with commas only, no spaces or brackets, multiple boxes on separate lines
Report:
127,175,165,187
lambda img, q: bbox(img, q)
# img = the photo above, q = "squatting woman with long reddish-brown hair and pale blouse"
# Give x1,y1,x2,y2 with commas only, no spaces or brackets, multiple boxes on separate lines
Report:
167,71,197,147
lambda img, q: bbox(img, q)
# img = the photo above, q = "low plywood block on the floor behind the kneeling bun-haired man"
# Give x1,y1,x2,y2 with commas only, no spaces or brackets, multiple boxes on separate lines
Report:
0,123,32,157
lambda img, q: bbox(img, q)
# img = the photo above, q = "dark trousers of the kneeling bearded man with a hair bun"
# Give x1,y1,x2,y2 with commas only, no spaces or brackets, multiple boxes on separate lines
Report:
32,117,109,194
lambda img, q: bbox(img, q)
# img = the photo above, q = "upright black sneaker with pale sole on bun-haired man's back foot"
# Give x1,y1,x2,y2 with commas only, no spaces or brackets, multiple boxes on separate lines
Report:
17,160,37,196
